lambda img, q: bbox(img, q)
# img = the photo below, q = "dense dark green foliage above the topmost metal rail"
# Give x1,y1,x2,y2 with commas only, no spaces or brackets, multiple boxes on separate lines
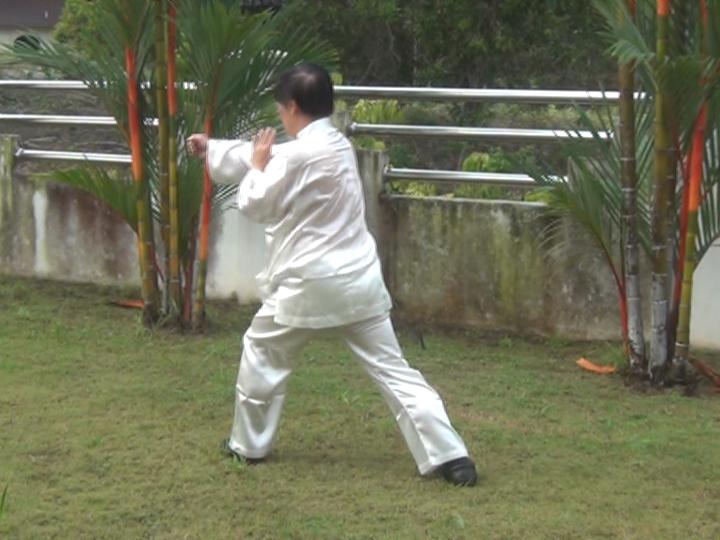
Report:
56,0,614,88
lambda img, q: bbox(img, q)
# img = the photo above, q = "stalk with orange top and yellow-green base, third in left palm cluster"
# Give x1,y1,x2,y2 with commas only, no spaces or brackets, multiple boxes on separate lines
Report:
165,0,183,318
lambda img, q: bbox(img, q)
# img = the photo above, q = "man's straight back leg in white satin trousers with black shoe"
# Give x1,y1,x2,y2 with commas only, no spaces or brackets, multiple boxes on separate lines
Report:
342,314,476,485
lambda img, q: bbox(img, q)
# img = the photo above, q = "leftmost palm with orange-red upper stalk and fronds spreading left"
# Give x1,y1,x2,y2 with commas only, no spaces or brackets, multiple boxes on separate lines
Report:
5,0,160,324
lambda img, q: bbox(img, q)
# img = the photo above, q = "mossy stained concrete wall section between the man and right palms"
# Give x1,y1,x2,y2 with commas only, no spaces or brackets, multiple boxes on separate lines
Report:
384,196,620,339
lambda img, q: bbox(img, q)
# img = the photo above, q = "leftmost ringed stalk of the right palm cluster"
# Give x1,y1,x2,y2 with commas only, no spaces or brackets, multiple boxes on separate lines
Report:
618,0,645,370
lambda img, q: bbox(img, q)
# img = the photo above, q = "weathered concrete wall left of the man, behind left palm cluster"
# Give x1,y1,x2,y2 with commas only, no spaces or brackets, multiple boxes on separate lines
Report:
0,167,265,302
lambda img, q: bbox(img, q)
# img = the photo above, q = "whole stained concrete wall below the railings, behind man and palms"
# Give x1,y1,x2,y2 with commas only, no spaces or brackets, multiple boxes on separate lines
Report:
0,137,720,349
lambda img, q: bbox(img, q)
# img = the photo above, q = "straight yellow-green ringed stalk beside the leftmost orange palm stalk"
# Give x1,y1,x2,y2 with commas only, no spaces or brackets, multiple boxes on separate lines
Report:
155,0,170,314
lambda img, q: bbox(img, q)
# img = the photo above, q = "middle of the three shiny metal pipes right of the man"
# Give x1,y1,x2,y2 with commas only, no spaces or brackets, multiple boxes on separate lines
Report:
348,123,610,141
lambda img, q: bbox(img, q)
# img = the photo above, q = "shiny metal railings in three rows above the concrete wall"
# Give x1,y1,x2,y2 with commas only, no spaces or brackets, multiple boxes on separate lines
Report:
0,80,619,184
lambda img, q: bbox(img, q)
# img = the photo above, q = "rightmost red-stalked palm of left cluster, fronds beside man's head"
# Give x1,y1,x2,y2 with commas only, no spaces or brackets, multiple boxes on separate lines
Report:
179,0,334,329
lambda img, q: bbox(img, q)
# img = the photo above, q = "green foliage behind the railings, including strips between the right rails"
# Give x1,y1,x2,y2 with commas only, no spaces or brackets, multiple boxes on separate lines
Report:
45,0,616,198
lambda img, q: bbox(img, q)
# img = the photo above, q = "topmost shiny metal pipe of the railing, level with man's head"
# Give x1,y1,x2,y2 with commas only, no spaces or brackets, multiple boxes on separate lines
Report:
0,80,620,104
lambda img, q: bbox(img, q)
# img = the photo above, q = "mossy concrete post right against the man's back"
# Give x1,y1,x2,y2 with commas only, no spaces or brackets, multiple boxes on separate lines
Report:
356,149,388,262
